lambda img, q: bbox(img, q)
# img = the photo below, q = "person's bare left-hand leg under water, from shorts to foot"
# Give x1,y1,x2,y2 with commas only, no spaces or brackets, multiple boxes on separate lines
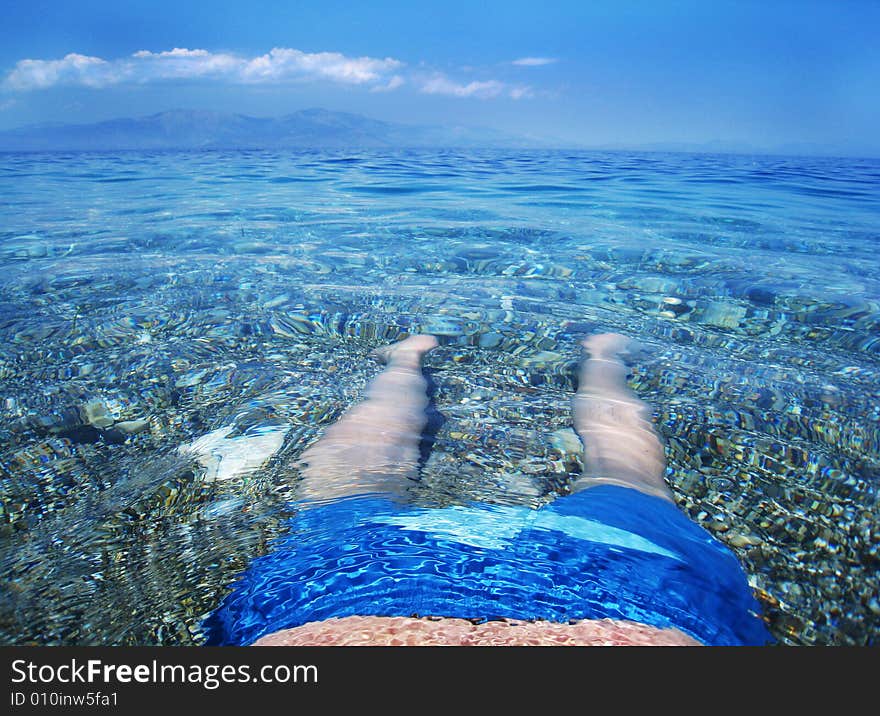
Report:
298,335,437,500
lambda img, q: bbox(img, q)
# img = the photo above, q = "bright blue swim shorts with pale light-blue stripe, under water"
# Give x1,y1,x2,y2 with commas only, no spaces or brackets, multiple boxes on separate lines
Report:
204,485,772,645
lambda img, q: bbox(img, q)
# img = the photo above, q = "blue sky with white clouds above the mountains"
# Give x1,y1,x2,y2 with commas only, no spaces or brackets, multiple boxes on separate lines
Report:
0,0,880,156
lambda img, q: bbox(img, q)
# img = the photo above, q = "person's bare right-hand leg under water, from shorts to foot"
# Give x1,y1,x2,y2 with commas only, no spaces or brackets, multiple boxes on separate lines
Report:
572,333,672,500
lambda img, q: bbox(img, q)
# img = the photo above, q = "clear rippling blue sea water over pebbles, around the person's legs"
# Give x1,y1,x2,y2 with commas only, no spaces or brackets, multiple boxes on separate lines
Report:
0,151,880,644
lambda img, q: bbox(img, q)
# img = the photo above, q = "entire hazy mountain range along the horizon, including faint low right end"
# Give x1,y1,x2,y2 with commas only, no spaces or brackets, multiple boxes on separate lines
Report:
0,109,860,156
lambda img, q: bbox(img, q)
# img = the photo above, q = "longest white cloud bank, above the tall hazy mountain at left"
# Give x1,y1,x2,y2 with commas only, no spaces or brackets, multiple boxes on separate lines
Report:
3,47,403,91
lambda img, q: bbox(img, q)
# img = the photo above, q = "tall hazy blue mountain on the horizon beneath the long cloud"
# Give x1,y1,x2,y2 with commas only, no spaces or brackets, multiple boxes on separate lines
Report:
0,109,541,151
